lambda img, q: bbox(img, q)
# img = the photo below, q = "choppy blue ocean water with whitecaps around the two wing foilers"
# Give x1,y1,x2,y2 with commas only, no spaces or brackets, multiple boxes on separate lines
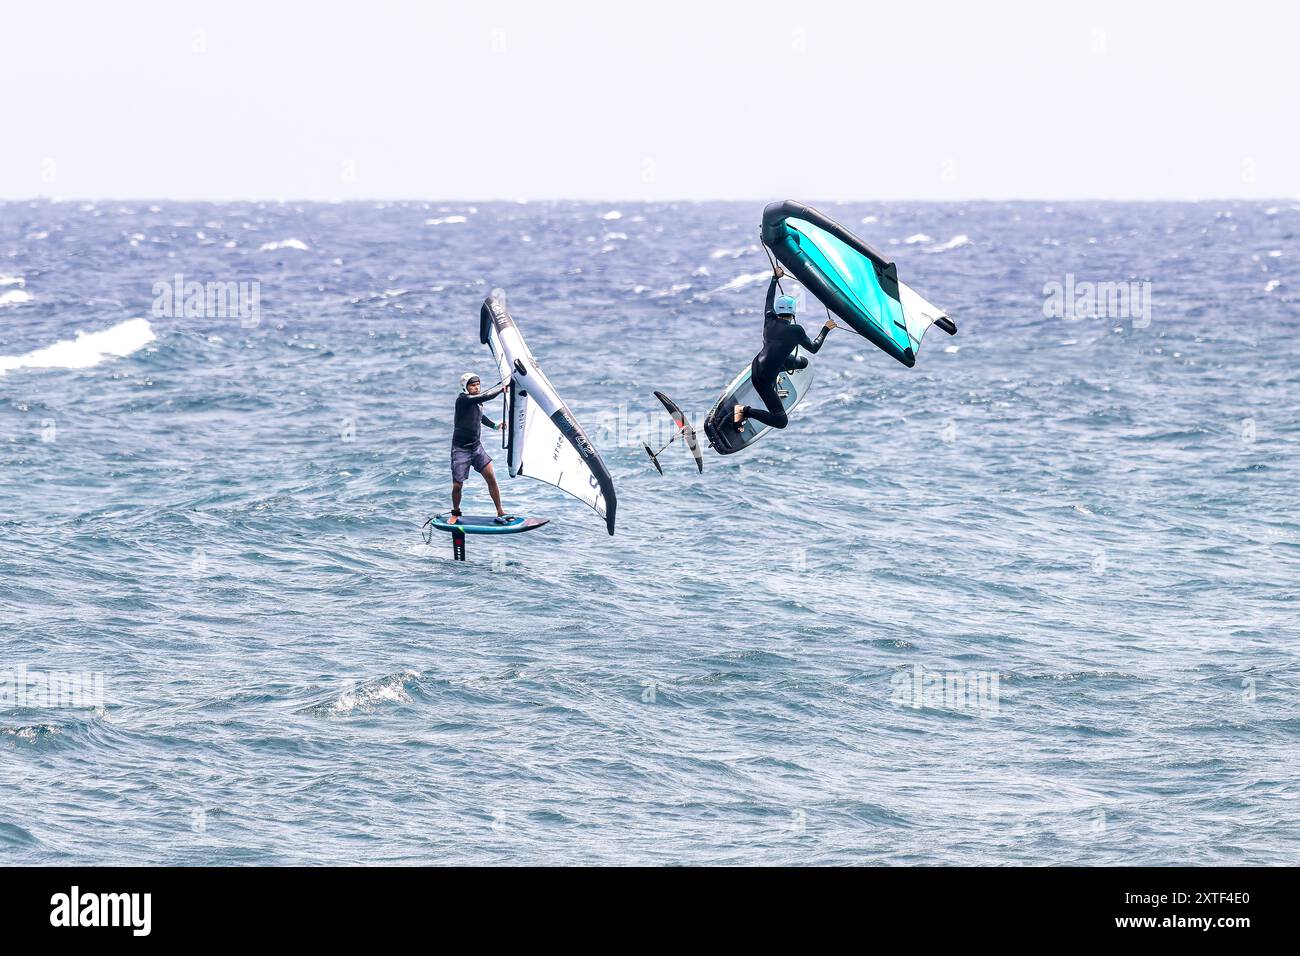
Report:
0,202,1300,865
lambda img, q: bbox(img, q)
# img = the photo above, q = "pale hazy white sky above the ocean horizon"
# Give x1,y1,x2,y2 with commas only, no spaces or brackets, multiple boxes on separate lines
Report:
0,0,1300,200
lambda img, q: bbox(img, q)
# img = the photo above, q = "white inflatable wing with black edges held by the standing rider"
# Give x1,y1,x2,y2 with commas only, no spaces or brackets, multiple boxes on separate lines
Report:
478,290,616,535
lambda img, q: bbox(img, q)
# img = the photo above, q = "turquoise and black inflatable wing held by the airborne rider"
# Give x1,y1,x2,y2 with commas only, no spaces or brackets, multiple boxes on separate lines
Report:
762,199,957,368
